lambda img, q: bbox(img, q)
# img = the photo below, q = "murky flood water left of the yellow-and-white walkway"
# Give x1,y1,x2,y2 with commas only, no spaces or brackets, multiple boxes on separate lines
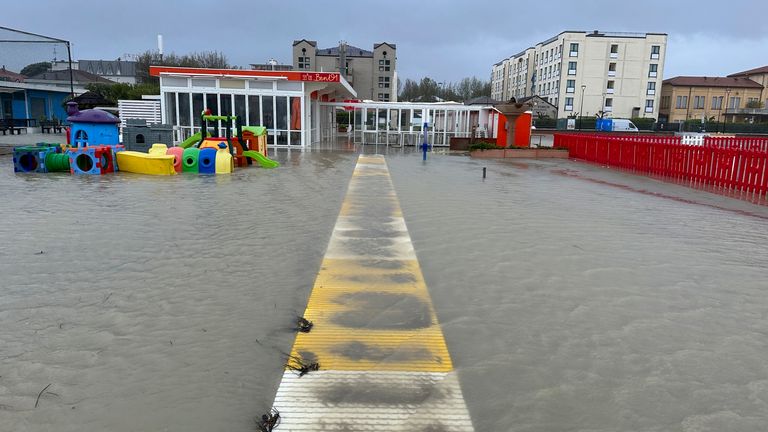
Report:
0,151,356,431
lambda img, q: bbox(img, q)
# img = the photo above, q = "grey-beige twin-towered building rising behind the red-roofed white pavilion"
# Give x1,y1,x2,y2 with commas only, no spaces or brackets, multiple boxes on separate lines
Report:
293,39,397,102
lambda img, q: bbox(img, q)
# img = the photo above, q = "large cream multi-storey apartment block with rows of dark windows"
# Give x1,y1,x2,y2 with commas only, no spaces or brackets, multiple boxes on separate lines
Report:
491,31,667,118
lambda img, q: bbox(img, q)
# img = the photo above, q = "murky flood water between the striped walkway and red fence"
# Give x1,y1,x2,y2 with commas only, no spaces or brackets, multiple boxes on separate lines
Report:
388,156,768,432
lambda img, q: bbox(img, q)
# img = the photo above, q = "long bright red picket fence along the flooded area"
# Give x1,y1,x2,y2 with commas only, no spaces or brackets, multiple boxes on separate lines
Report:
555,134,768,203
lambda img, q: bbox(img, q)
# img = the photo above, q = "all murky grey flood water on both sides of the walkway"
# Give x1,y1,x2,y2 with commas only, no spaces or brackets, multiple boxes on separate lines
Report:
0,146,768,432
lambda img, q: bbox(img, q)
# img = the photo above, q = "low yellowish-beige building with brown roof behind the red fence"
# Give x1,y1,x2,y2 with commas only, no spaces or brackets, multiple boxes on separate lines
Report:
659,72,768,123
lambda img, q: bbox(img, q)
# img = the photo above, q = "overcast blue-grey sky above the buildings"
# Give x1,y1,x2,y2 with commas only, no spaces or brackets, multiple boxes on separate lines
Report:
0,0,768,81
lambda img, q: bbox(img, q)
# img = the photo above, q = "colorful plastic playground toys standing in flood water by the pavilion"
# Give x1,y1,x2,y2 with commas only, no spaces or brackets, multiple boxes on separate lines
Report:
13,102,279,175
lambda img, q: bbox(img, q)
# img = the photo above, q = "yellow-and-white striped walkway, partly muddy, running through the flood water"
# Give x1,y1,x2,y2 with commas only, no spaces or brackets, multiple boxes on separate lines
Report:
274,156,473,432
